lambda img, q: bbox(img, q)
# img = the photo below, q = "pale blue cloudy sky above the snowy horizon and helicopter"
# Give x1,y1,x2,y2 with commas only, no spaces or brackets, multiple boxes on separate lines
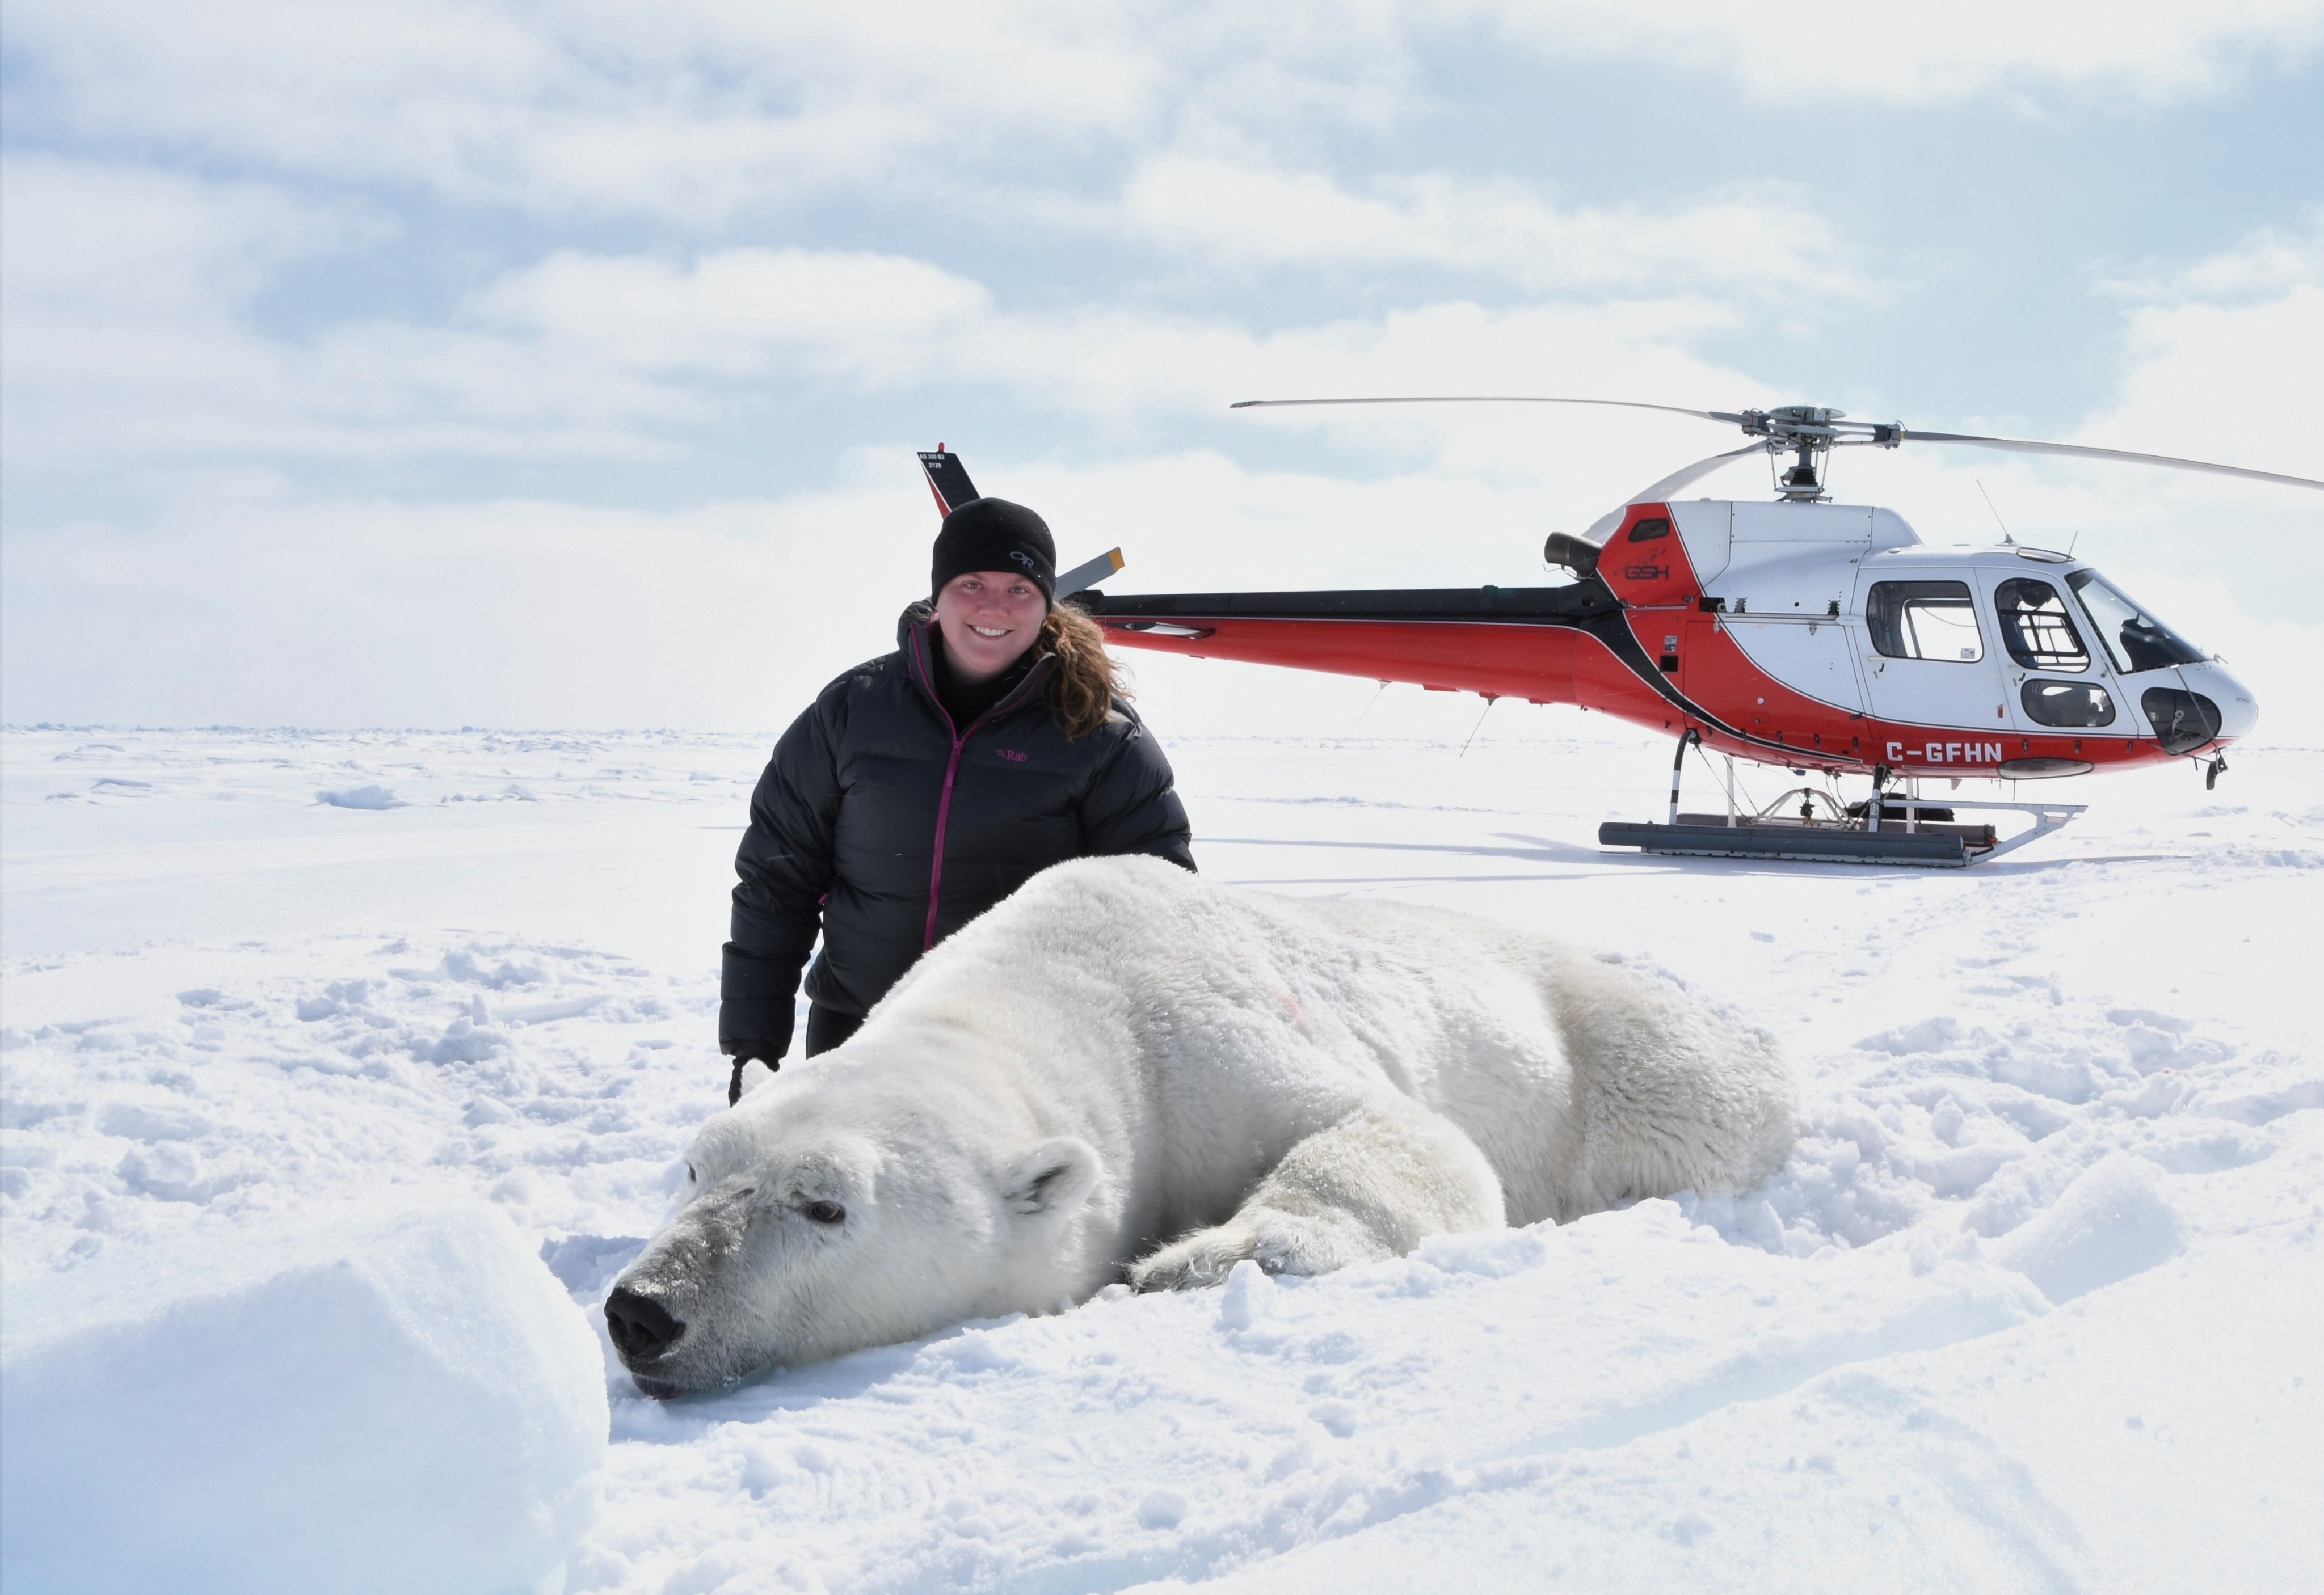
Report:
0,0,2324,731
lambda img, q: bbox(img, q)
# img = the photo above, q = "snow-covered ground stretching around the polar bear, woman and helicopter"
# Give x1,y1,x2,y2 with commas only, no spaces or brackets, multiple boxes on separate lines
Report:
0,715,2324,1595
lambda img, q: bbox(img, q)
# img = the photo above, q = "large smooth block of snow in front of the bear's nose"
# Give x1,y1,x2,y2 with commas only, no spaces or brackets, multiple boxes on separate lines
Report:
0,1198,607,1595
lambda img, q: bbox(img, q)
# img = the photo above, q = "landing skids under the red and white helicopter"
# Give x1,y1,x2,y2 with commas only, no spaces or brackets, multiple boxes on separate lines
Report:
1599,731,2085,868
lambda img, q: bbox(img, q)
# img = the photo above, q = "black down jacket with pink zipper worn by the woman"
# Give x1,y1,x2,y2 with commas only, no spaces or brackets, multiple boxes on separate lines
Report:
718,604,1194,1058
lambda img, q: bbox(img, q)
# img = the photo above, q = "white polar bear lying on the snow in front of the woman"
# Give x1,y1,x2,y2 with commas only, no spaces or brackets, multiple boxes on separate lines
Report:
607,856,1796,1395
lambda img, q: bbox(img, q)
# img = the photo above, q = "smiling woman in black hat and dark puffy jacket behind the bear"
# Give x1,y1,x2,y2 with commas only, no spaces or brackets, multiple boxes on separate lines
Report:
718,499,1194,1103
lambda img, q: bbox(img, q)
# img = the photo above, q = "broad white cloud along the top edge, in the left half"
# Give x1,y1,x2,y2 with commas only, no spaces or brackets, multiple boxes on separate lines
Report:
11,0,1204,221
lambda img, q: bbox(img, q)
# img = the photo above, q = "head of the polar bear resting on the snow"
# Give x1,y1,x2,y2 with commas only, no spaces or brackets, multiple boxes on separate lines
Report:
604,1047,1102,1398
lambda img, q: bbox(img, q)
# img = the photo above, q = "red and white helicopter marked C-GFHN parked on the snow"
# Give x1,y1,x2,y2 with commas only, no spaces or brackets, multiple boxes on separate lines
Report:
920,397,2324,866
